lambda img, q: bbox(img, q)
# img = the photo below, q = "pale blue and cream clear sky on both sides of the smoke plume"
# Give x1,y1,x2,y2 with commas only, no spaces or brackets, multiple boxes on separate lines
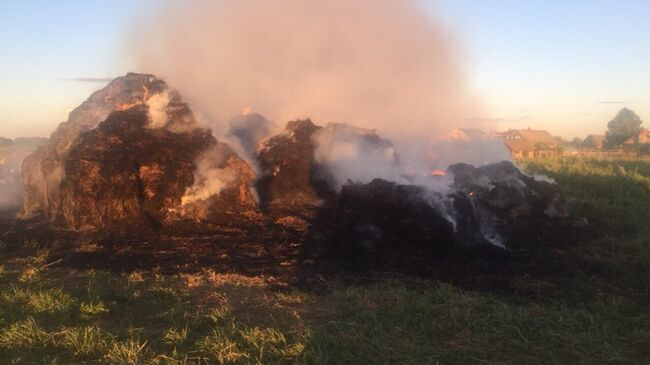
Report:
0,0,650,139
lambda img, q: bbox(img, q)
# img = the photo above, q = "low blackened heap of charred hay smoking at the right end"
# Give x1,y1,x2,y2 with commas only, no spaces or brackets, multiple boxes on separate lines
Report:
329,161,567,256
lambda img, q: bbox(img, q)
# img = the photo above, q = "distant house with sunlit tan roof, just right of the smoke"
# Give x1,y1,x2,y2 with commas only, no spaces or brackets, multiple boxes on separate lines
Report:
495,128,560,158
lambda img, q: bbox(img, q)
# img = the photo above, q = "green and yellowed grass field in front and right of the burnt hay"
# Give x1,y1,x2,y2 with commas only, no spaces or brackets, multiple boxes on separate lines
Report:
0,159,650,364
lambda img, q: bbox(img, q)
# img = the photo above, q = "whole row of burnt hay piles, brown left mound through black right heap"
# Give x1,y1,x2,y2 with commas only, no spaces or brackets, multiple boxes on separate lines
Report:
8,74,566,258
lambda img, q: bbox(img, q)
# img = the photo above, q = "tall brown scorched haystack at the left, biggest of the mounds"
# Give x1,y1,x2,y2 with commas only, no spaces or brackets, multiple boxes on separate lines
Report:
18,74,256,229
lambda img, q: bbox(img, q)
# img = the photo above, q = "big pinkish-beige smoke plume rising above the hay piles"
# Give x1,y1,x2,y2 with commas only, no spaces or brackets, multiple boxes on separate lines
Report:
127,0,506,176
